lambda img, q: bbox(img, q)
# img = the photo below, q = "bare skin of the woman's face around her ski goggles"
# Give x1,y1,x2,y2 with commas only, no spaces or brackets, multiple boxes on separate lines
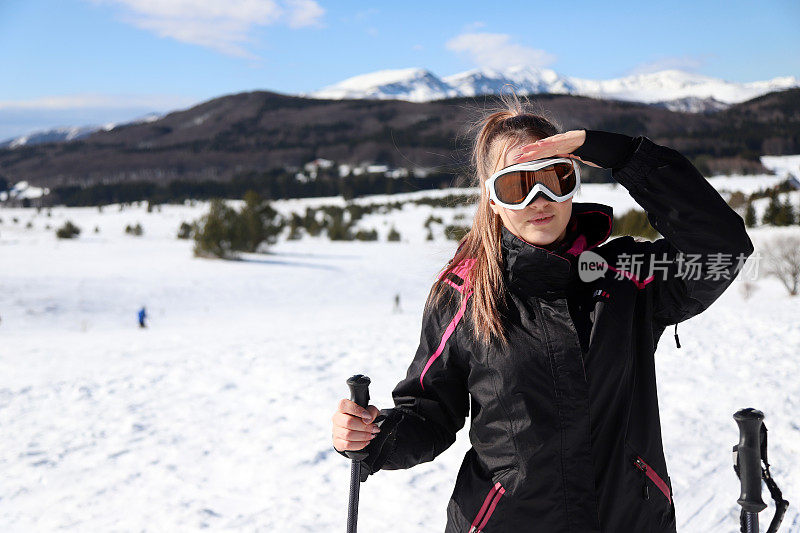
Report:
489,139,572,246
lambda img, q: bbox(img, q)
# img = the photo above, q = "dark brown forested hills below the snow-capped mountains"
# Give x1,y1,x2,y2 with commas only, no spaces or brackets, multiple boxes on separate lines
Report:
0,85,800,187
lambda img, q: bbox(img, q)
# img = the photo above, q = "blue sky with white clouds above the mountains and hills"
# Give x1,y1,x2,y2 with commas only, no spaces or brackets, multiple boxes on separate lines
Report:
0,0,800,139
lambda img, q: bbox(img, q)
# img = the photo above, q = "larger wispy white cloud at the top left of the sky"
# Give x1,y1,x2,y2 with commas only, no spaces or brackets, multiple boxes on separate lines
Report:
90,0,325,58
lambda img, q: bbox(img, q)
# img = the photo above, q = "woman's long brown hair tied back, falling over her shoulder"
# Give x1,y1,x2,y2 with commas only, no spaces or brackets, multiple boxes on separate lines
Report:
431,92,561,344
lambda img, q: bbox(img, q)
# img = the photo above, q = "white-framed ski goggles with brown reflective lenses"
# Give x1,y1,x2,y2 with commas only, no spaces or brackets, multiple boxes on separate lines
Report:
485,158,581,209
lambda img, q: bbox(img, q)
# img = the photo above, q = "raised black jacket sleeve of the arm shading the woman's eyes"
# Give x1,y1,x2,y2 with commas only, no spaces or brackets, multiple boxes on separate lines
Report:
576,130,753,326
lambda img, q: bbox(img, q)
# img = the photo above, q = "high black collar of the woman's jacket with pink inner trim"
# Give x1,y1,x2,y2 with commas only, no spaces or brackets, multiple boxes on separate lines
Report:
500,202,614,296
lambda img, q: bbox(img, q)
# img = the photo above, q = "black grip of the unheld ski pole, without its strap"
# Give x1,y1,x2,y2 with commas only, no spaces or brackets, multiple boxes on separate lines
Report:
733,407,767,513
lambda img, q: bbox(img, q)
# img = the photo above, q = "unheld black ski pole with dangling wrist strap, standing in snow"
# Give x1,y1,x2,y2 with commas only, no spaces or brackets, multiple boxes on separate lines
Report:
733,408,789,533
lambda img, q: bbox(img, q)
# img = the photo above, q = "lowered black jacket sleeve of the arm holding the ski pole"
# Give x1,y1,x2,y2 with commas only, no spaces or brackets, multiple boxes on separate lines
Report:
339,289,469,481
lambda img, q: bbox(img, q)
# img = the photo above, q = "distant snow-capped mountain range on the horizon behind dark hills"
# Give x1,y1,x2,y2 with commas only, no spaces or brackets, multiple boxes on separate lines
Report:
302,66,800,112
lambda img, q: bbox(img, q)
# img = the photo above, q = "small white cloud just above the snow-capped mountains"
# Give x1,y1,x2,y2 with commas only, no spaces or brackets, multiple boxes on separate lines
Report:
445,33,556,69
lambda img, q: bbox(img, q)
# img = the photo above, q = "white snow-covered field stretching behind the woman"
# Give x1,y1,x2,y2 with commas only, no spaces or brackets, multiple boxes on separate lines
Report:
0,165,800,533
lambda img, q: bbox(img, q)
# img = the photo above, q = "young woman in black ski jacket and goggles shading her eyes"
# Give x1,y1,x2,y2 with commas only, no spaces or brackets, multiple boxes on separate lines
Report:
332,96,753,533
